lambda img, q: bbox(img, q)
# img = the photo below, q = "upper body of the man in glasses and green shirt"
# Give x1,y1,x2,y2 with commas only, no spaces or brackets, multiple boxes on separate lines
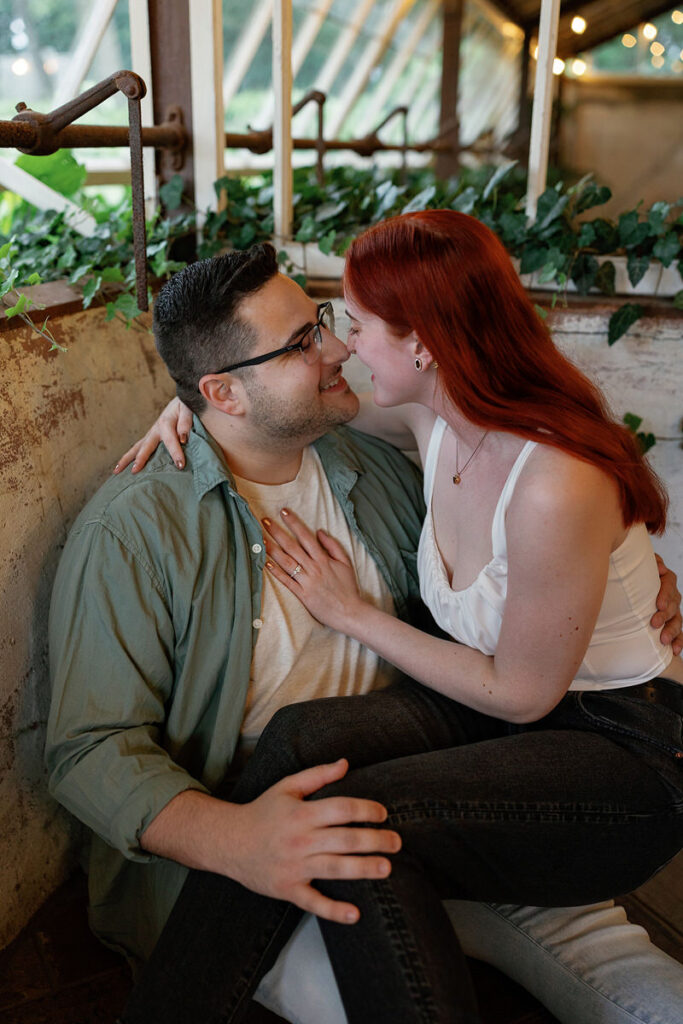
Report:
47,246,683,1019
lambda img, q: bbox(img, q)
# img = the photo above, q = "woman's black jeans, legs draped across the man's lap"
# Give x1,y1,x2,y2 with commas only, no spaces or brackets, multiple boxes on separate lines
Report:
123,680,683,1024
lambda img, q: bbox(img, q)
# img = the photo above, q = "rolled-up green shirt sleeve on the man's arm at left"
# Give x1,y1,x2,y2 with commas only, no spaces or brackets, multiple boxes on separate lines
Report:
46,522,206,861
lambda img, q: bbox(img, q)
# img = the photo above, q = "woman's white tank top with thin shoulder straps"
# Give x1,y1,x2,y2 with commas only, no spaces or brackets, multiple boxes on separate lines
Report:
418,418,673,690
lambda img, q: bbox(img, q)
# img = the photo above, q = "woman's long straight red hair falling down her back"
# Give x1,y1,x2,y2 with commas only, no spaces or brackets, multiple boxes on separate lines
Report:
344,210,668,534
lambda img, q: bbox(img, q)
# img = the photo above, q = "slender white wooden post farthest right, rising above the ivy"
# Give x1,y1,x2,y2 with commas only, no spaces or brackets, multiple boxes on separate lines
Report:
526,0,560,220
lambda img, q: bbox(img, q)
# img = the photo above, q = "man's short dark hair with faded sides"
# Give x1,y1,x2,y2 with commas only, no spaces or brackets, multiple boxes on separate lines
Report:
154,242,278,413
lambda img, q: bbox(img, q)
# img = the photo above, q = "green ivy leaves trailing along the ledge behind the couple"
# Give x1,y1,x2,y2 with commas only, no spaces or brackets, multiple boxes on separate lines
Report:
0,152,683,354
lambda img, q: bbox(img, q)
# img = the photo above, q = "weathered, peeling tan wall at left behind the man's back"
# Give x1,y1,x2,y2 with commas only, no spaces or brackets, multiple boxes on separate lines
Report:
0,309,172,947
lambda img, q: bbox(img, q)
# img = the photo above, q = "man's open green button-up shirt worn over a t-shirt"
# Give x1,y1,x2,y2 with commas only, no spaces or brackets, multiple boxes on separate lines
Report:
46,418,424,961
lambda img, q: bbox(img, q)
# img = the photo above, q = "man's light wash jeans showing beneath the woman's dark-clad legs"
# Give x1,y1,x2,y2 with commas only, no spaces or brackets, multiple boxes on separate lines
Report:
254,900,683,1024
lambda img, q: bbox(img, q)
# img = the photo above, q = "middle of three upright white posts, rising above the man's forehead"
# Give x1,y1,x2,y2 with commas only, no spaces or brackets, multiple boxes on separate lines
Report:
272,0,293,245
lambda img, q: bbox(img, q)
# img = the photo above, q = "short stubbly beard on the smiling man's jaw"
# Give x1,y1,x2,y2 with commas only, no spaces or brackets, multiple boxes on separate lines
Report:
244,368,358,450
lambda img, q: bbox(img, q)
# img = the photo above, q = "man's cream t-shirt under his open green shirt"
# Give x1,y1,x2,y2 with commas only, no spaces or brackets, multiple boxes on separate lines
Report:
234,447,395,748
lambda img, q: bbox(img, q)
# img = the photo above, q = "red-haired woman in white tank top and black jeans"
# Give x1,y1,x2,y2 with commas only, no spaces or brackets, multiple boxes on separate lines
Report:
118,211,683,1021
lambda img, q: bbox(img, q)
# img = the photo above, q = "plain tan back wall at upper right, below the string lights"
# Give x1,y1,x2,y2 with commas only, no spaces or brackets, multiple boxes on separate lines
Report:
558,76,683,217
